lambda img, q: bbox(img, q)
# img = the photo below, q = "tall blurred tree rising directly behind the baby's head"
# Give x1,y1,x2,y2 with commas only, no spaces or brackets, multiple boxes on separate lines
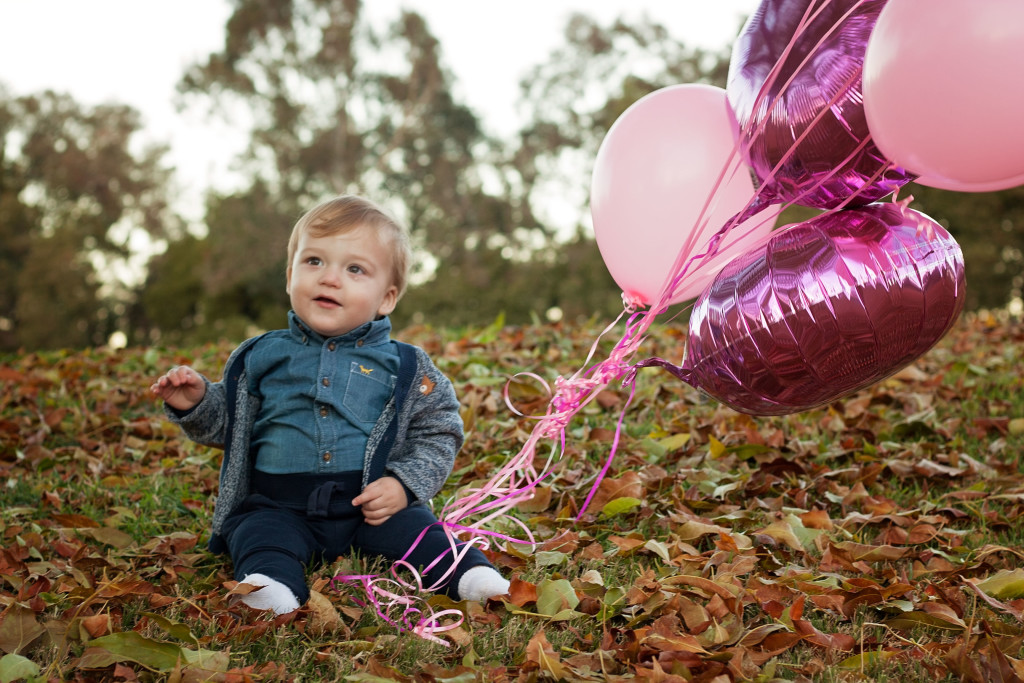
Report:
173,0,529,331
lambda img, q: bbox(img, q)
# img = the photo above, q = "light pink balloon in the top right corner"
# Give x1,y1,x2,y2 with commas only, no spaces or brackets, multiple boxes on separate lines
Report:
863,0,1024,191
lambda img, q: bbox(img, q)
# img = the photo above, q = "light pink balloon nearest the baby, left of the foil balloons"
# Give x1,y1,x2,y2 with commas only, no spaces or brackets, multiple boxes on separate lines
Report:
591,84,778,304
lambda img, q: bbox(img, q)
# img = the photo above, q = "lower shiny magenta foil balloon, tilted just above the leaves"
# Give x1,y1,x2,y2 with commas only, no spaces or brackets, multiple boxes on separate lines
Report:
637,204,965,415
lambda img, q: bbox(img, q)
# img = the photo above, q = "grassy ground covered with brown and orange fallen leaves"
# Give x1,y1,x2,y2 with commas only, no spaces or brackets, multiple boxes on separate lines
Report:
0,315,1024,682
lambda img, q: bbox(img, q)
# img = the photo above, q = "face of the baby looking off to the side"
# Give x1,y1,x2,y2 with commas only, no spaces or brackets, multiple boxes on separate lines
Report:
288,225,398,337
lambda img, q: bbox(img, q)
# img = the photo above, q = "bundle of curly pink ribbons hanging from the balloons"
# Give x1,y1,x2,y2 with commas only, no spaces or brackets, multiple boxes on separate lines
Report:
332,0,912,646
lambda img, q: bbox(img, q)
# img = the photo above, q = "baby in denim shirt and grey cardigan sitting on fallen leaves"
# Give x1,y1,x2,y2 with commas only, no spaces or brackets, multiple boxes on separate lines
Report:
152,196,509,613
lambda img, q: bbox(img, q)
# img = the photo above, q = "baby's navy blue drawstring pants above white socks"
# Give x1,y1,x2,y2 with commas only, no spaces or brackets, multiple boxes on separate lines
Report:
223,472,490,604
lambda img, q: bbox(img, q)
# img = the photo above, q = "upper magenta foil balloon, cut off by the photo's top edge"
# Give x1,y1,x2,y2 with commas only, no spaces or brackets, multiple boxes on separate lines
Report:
726,0,913,214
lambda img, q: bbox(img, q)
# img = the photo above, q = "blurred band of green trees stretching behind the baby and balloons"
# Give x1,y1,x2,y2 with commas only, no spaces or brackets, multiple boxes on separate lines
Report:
0,7,1024,350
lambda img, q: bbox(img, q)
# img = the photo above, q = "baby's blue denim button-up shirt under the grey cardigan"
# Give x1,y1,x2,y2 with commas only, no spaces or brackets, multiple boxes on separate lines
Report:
246,311,398,474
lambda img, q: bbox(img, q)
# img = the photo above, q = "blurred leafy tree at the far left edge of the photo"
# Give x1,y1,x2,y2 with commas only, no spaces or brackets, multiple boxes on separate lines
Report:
0,89,175,350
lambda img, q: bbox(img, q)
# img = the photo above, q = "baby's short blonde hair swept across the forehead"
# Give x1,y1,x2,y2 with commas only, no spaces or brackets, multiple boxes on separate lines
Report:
288,195,413,299
